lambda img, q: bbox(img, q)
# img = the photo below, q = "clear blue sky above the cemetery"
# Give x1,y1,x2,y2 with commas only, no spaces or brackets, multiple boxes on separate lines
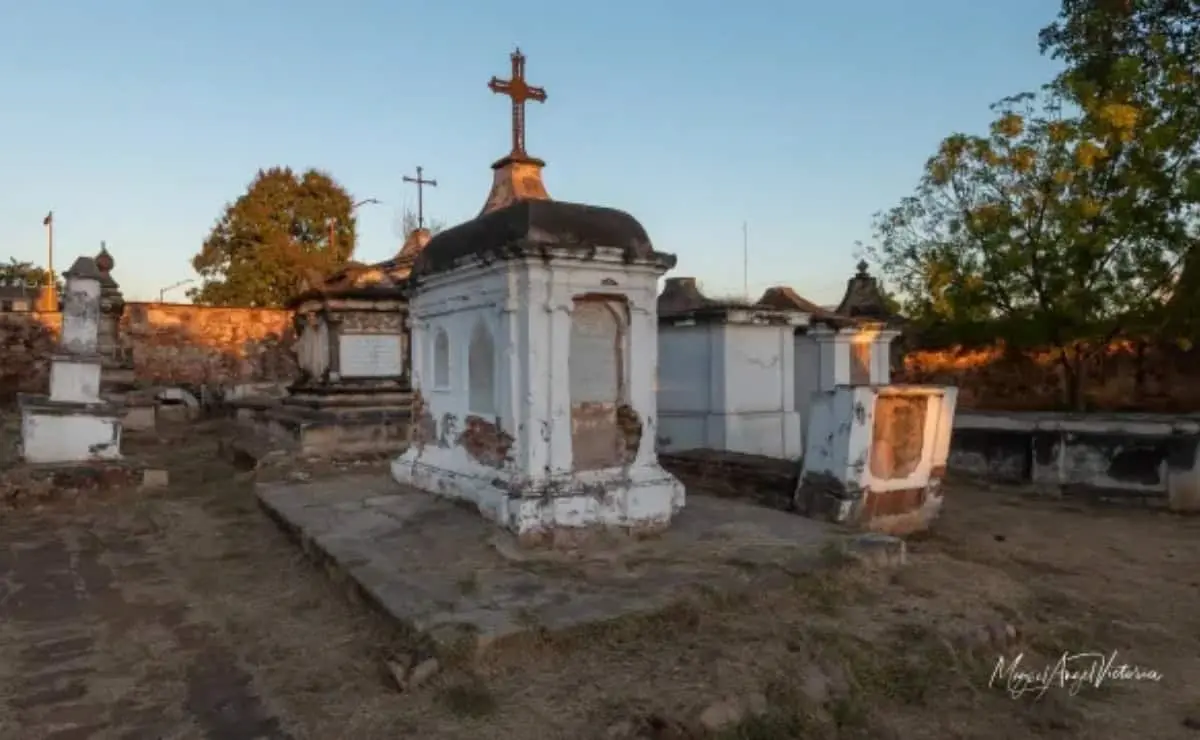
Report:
0,0,1058,302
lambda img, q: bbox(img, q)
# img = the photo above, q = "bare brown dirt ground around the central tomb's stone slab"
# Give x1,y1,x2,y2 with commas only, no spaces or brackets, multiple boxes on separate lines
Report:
0,417,1200,740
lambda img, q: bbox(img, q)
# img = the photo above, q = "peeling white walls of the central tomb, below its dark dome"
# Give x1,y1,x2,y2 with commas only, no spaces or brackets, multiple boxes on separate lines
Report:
392,248,684,535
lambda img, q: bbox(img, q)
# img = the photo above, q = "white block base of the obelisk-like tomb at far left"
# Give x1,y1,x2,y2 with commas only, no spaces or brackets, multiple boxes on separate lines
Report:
20,396,121,463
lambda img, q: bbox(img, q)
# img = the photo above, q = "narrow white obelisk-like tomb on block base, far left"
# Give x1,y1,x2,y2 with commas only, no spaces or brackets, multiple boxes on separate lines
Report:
20,257,121,463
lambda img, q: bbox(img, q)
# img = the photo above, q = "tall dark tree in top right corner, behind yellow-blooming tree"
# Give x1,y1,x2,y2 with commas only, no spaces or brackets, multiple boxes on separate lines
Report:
1039,0,1200,335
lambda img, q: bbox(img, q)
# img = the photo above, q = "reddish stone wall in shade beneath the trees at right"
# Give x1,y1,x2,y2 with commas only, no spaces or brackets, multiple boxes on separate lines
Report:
893,342,1200,414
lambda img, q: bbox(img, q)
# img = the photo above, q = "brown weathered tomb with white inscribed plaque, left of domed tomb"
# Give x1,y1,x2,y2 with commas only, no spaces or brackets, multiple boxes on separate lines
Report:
254,229,430,456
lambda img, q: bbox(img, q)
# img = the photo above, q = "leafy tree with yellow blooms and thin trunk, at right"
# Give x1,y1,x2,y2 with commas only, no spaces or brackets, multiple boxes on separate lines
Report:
874,90,1190,408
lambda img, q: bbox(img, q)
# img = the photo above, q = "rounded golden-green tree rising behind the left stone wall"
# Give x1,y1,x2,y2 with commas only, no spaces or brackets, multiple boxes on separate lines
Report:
188,167,355,307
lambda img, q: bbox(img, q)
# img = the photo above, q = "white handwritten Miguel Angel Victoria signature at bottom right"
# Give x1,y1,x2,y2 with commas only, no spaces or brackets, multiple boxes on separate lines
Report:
988,650,1163,699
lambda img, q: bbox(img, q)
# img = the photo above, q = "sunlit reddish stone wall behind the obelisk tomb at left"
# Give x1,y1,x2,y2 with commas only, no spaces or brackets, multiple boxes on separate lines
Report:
0,303,295,401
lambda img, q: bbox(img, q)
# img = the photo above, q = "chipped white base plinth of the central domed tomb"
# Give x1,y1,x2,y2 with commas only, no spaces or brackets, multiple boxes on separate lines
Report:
391,445,685,545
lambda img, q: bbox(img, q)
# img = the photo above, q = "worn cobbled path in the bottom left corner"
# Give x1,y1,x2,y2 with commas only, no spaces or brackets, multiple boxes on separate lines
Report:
0,512,292,740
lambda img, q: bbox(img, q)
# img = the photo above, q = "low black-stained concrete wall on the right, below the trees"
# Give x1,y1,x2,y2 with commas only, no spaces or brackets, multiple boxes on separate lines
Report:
948,411,1200,511
